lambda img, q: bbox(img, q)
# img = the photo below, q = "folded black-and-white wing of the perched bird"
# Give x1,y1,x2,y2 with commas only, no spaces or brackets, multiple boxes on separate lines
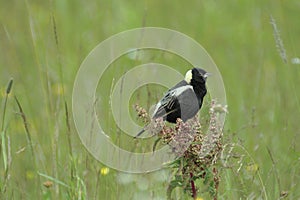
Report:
152,85,193,118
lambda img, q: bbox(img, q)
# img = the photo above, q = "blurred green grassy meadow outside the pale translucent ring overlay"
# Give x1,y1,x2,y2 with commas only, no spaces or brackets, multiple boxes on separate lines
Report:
0,0,300,199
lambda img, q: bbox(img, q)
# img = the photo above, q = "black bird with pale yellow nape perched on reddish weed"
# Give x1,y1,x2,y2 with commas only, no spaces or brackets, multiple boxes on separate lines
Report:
135,68,210,138
